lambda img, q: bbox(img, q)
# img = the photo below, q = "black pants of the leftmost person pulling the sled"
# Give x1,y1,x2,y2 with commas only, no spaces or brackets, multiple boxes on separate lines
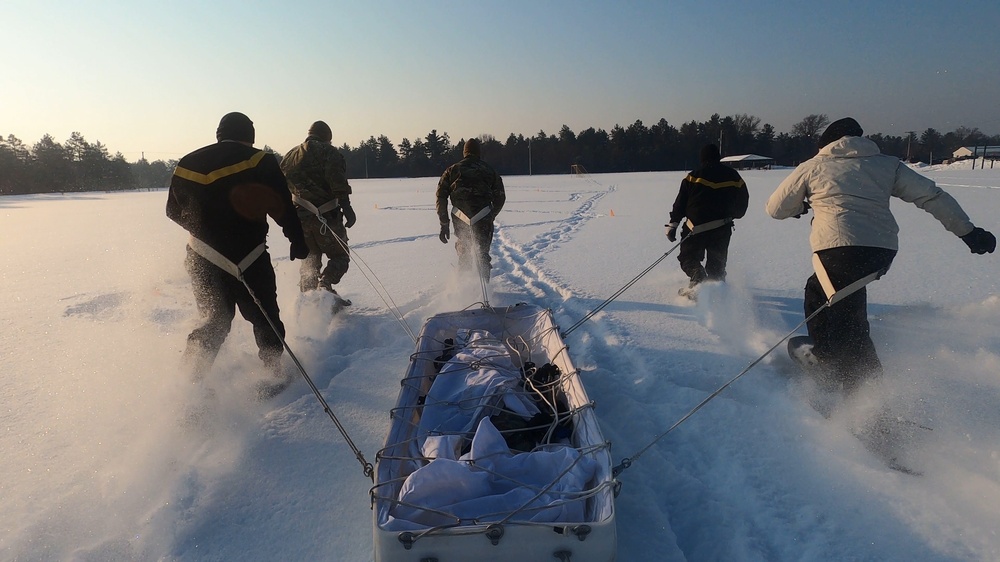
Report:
184,247,285,377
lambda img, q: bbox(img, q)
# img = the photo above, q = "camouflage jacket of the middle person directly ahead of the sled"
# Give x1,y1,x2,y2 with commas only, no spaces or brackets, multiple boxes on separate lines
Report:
437,155,507,224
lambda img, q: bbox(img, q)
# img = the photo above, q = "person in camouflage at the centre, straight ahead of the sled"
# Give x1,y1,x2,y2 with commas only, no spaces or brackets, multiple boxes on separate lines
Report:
436,139,507,280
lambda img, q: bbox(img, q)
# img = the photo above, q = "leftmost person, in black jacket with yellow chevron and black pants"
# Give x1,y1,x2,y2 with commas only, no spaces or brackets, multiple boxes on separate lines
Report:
167,113,309,399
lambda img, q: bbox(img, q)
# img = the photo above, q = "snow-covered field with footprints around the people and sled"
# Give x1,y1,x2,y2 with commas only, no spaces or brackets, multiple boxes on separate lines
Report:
0,163,1000,562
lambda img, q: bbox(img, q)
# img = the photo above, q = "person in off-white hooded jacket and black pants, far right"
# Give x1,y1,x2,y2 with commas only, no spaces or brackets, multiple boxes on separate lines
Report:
766,117,996,391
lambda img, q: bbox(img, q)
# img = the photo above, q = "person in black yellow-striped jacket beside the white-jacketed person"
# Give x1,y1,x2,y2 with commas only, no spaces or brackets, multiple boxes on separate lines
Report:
666,144,750,296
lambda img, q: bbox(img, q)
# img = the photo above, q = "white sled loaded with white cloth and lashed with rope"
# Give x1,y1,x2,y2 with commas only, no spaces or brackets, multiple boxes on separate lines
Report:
371,304,617,562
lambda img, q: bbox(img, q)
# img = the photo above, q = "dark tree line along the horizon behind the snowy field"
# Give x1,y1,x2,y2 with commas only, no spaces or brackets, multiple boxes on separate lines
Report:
0,114,1000,195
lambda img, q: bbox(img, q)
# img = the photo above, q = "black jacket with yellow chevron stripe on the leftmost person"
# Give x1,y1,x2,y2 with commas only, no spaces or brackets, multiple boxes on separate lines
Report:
167,141,305,263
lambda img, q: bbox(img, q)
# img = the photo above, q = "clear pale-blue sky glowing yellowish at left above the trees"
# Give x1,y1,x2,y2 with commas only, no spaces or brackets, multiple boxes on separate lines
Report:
0,0,1000,161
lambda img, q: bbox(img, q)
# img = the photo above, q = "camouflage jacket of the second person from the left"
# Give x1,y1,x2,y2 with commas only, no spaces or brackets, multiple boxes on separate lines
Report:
281,135,351,214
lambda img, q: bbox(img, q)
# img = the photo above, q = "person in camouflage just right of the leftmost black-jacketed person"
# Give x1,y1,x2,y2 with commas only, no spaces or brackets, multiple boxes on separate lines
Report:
281,121,357,304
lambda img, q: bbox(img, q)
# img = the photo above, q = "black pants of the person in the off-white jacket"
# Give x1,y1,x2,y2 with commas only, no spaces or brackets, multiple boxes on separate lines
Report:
804,246,896,390
